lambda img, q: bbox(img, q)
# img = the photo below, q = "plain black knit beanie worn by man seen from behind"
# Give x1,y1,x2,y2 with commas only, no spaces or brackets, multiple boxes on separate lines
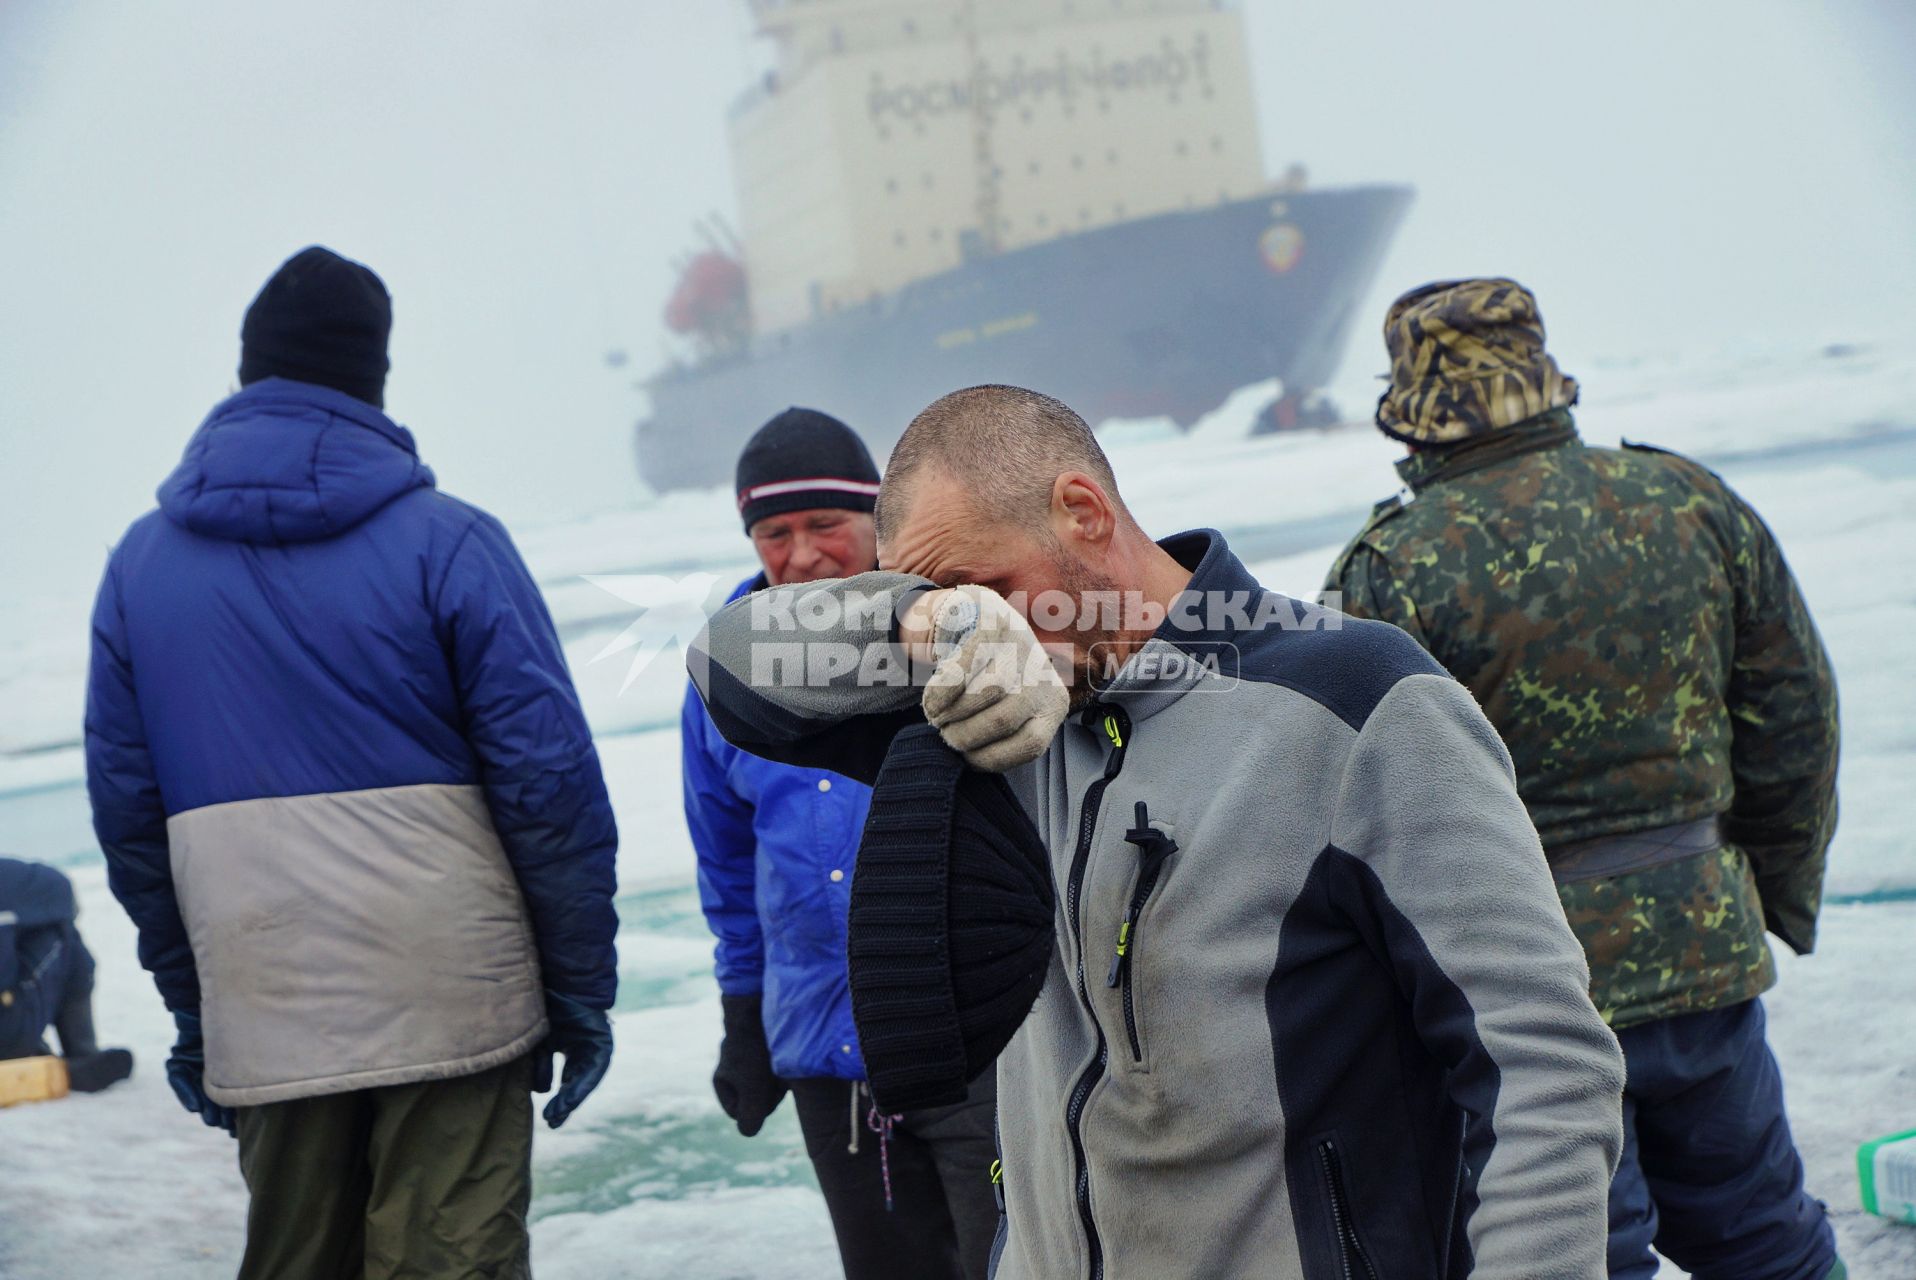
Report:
240,245,393,406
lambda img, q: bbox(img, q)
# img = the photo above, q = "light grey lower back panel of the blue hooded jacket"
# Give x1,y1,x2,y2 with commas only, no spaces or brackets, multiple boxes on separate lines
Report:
167,786,546,1106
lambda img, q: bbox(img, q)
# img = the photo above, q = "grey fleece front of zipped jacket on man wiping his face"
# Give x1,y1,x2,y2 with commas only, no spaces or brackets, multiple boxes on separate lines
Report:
998,676,1353,1280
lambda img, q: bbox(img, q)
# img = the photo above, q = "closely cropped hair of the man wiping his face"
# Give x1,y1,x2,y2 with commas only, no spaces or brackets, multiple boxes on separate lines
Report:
876,383,1125,538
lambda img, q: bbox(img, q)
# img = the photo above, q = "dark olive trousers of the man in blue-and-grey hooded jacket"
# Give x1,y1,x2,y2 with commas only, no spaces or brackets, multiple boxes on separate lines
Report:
236,1058,533,1280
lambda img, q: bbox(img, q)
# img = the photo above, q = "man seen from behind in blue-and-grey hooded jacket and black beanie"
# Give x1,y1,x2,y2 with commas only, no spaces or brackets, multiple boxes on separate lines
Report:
86,247,617,1280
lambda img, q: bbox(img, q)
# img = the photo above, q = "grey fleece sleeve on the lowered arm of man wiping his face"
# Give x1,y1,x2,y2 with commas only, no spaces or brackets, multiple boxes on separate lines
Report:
1332,676,1623,1280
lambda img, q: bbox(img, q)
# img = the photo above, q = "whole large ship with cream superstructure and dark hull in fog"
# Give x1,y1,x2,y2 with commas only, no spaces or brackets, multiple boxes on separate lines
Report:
640,0,1408,487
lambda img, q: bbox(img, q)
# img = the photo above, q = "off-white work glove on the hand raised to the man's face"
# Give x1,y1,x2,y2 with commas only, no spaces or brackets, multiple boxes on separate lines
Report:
922,586,1071,774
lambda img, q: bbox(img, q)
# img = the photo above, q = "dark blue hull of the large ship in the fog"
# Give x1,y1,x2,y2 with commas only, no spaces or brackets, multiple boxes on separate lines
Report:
636,186,1410,491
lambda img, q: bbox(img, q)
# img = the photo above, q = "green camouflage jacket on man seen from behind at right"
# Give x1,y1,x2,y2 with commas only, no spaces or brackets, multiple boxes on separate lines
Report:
1328,410,1837,1027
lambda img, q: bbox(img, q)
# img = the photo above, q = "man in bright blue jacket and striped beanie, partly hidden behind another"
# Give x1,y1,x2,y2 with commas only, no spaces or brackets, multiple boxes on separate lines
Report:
680,408,998,1280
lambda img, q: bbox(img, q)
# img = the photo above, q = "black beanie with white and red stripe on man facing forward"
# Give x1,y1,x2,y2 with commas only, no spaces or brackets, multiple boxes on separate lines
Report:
736,408,878,533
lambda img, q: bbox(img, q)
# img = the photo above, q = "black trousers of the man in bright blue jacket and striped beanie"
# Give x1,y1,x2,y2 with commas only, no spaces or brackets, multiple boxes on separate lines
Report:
791,1071,998,1280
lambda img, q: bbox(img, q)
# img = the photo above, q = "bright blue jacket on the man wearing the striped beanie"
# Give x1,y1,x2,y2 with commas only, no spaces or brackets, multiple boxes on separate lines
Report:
680,575,872,1081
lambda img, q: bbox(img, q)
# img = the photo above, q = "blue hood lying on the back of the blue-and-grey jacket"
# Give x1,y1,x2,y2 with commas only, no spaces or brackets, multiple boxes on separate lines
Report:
159,377,433,544
